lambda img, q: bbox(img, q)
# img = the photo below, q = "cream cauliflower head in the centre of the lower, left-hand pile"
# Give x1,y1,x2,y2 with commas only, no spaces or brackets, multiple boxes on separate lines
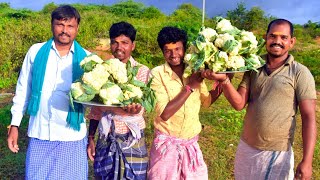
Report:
82,64,110,94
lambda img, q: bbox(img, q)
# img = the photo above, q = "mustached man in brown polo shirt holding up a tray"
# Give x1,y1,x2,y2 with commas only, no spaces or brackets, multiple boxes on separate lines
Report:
206,19,316,179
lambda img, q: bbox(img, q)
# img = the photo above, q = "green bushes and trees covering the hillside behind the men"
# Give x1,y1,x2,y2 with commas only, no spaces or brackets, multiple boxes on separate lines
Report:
0,1,320,92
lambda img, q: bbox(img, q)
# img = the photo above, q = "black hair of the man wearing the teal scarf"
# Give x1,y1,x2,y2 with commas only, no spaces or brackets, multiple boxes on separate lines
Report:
51,5,81,24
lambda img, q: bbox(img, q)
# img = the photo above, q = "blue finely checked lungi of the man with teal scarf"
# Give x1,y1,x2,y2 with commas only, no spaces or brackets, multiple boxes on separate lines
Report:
26,138,88,180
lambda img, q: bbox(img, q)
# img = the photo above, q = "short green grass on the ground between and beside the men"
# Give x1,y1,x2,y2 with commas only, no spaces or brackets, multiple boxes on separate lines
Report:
0,76,320,180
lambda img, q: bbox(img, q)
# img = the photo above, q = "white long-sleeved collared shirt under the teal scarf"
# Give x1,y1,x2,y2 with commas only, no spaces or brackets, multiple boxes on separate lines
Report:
11,42,89,141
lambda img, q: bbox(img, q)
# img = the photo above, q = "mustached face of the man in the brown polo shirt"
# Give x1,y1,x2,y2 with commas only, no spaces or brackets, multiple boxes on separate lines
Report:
266,23,295,58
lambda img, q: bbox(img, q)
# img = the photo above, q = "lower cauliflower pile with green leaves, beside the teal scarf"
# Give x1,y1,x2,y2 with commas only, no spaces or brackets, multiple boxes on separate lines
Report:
69,54,156,112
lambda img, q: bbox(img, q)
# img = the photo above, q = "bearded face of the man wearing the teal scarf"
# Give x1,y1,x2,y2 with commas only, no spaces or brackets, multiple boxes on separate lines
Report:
51,18,79,45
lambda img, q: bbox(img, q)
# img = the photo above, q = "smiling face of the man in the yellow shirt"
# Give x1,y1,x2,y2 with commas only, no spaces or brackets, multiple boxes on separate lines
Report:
163,41,184,66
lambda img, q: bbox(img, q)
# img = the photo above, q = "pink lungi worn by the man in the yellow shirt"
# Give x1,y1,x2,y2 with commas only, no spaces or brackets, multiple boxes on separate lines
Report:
148,131,208,180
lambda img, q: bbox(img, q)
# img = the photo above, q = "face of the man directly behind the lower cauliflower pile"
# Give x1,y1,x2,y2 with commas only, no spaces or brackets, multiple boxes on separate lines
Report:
110,35,135,63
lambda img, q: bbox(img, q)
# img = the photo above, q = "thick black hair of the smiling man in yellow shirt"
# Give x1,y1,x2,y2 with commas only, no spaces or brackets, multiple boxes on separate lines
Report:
157,26,188,51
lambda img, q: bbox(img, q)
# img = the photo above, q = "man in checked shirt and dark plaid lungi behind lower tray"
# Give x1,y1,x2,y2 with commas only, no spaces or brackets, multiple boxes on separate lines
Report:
87,22,150,179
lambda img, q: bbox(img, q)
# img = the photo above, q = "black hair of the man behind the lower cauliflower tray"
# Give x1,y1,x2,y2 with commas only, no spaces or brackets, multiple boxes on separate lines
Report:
109,21,137,42
